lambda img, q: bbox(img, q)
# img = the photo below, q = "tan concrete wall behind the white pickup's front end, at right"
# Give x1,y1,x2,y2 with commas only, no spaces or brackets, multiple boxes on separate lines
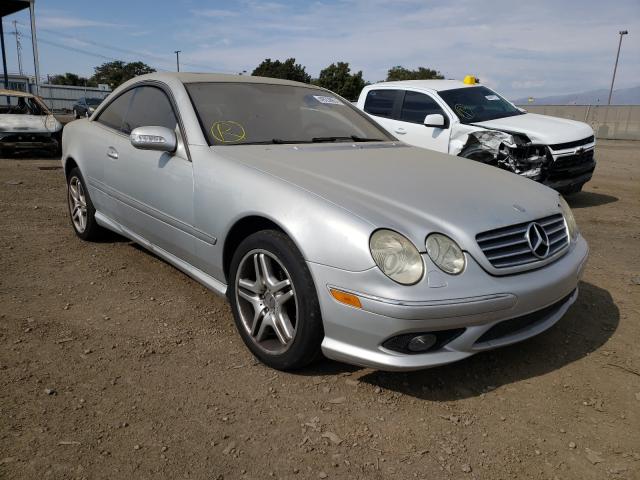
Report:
521,105,640,140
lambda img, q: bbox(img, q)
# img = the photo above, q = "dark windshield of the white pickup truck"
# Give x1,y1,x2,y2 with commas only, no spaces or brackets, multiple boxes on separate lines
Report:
438,87,522,123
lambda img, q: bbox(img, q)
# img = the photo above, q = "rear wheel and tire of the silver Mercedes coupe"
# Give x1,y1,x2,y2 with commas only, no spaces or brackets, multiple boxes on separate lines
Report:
67,167,105,241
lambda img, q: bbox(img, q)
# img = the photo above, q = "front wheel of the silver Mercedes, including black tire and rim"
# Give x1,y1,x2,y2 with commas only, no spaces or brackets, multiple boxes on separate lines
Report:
228,230,324,371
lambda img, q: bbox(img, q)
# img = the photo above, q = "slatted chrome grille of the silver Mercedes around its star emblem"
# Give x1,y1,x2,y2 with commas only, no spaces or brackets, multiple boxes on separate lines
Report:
476,213,569,268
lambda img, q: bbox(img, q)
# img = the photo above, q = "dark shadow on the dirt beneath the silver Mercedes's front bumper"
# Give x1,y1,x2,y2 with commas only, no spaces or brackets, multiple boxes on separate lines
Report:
312,282,620,401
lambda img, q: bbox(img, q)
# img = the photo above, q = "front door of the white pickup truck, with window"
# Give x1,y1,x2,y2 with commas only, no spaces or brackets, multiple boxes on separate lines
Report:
392,90,451,153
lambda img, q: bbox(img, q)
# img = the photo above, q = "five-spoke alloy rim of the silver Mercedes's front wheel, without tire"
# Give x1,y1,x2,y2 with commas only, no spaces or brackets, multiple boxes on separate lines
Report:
235,250,298,355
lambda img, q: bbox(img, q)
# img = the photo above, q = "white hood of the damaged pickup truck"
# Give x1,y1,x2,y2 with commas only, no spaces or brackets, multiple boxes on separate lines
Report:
474,113,593,145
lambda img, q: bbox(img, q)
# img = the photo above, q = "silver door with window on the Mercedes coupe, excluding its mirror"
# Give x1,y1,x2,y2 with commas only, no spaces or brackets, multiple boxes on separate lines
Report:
105,85,194,262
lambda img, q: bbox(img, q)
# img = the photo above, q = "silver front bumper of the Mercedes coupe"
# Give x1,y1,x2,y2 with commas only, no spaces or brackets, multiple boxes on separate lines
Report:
308,237,588,370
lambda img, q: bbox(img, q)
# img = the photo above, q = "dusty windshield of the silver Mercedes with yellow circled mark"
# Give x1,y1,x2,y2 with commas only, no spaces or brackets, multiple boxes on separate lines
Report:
186,82,393,145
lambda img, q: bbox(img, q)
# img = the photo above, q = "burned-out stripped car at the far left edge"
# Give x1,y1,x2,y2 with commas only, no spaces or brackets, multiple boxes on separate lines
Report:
0,89,62,156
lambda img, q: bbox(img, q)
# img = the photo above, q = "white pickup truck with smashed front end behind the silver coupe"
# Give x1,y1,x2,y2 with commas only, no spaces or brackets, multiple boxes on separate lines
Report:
357,76,596,193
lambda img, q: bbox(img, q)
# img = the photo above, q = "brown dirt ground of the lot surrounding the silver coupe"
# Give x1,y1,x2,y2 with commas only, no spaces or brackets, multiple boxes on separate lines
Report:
0,141,640,480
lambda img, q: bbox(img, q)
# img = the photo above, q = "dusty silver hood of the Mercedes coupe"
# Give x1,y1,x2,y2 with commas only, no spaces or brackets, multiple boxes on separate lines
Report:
212,143,560,251
